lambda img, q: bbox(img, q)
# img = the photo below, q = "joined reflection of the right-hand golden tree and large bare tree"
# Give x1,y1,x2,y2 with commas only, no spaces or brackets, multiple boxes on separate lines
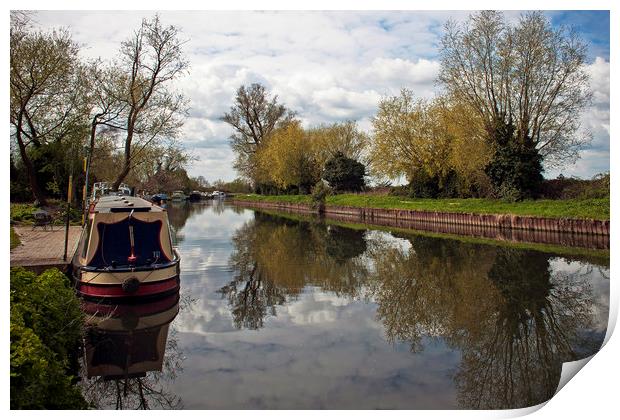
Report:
372,233,600,409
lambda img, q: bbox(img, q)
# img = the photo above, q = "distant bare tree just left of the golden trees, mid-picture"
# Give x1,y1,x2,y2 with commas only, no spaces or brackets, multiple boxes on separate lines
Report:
222,83,295,180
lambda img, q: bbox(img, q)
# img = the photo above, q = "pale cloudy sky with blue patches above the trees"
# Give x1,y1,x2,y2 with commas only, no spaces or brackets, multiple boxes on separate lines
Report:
30,11,610,181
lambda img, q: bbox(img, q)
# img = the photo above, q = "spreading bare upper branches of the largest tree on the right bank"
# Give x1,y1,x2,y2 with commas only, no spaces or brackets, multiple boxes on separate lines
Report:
439,11,591,165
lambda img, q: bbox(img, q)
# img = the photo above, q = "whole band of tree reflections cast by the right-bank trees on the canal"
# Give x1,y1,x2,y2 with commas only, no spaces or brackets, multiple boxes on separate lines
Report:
220,212,601,409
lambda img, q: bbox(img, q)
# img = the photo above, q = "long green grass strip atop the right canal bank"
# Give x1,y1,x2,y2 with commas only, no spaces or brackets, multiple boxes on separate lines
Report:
235,194,609,220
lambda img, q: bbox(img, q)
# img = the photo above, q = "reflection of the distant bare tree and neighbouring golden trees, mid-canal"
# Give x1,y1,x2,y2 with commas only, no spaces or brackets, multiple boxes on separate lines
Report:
220,212,367,329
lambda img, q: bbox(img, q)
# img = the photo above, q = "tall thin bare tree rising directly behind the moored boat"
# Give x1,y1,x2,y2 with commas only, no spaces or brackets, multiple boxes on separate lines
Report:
113,15,189,189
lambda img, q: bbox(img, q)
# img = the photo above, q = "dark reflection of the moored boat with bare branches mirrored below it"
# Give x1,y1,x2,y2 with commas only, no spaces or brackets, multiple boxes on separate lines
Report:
82,293,181,409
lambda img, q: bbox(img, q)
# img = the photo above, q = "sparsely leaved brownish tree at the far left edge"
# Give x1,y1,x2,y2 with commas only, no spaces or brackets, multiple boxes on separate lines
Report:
10,12,86,204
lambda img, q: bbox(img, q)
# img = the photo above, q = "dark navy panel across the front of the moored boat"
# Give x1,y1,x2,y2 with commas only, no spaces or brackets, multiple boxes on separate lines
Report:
88,218,170,267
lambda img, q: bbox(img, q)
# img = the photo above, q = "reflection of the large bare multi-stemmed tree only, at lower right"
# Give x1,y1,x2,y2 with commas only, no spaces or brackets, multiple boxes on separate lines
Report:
455,249,600,409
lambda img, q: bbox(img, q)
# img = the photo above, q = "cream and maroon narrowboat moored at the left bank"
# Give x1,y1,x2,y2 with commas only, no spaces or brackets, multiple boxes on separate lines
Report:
72,196,180,300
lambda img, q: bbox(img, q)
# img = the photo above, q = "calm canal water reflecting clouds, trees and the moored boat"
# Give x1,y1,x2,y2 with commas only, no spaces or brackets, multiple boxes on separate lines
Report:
83,204,609,409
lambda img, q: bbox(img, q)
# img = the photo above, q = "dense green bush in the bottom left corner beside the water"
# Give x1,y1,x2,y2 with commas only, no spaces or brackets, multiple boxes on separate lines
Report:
11,267,87,409
